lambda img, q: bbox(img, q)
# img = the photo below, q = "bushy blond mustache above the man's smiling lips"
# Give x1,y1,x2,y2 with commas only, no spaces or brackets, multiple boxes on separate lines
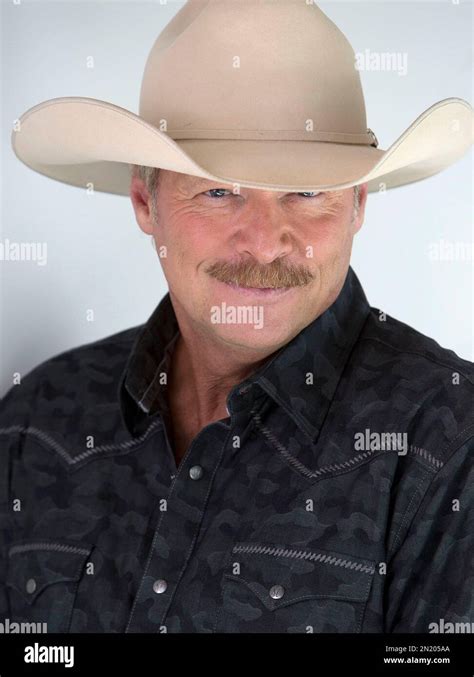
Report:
206,259,313,288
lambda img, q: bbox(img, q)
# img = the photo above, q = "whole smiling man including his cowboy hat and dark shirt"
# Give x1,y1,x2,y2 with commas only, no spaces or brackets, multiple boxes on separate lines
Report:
0,0,474,633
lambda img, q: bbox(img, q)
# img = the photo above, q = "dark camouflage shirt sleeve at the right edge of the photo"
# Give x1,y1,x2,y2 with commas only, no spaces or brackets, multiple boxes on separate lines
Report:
384,437,474,633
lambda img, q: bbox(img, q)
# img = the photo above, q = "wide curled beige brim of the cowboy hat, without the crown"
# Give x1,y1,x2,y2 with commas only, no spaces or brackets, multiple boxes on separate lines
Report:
12,97,473,195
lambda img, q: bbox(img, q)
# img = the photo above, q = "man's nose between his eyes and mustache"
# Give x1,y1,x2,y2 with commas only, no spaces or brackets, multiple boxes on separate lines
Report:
233,196,294,264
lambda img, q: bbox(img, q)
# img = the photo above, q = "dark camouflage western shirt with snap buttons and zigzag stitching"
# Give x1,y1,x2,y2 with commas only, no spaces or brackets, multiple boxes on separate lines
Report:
0,268,474,633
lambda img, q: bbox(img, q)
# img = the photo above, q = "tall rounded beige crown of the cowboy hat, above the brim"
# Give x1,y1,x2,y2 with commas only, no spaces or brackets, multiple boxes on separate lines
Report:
139,0,373,144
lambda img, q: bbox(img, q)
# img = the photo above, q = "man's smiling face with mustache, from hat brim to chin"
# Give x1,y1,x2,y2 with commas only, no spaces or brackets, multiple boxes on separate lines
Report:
131,170,367,354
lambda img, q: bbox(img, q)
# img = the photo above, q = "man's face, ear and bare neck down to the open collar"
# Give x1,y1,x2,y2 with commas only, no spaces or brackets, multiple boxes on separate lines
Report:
131,170,367,468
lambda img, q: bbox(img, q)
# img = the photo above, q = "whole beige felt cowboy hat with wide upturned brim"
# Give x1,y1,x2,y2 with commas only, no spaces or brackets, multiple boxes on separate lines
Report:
12,0,473,195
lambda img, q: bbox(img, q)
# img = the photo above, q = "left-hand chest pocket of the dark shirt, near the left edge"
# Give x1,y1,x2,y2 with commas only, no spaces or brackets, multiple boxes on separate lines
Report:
5,540,94,632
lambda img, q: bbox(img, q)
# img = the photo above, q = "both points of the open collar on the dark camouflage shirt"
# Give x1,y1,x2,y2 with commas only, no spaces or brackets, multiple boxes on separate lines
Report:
118,267,370,442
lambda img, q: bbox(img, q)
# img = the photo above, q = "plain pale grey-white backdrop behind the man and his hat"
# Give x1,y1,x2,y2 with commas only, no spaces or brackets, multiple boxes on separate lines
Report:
0,0,474,395
